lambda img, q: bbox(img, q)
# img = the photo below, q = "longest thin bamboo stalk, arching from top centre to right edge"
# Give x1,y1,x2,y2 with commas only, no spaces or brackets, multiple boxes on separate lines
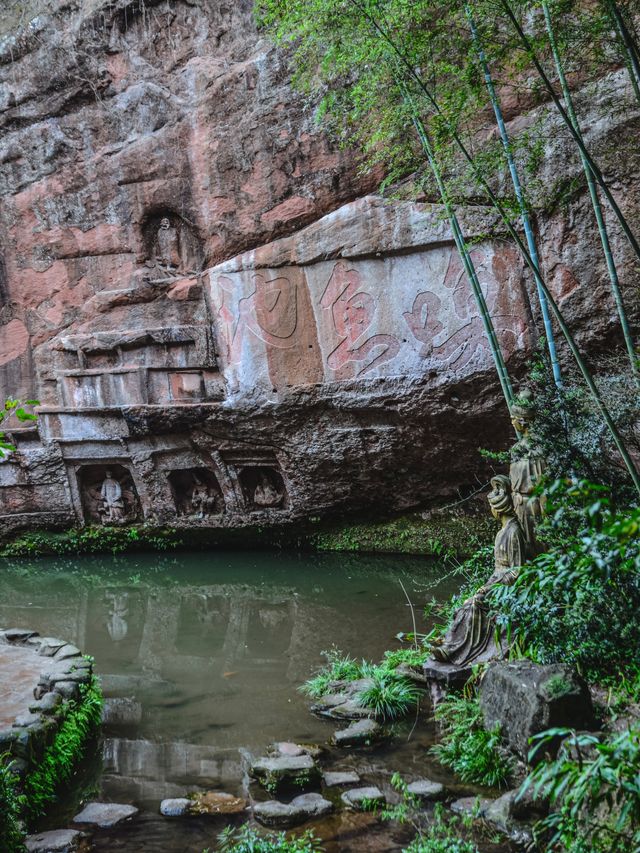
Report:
350,0,640,494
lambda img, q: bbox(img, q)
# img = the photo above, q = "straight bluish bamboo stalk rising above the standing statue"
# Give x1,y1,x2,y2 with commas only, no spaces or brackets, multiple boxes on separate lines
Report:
465,3,562,388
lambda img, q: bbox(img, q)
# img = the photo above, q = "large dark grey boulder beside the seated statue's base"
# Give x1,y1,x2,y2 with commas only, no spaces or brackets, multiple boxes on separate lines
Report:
480,660,594,760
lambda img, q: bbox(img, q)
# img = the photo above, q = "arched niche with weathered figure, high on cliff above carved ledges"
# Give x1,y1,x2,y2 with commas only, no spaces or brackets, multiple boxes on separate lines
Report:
142,209,205,277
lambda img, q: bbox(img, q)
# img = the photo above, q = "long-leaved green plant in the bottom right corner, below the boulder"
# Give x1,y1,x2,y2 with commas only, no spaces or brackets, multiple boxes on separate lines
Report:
521,726,640,853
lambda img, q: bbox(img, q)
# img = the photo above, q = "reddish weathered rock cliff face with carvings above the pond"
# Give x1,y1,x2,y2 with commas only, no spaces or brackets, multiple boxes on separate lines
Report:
0,0,639,532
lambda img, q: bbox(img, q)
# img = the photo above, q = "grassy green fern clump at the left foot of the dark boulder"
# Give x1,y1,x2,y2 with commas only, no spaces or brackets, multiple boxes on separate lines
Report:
432,695,512,787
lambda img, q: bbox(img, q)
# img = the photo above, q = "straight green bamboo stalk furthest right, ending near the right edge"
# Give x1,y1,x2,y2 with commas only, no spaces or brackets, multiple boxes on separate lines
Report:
541,0,638,377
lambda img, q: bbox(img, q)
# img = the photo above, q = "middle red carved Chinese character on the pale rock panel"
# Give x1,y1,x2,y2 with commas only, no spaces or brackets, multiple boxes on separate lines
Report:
320,262,400,379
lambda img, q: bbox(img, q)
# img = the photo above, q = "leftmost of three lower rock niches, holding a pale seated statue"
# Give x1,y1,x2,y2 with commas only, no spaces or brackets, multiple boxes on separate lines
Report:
77,462,141,524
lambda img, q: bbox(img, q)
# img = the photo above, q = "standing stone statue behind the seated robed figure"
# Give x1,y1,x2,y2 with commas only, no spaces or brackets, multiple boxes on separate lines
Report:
509,392,546,558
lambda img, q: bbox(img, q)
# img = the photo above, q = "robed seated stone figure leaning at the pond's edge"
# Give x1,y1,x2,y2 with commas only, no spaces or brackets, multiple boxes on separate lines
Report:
431,474,525,667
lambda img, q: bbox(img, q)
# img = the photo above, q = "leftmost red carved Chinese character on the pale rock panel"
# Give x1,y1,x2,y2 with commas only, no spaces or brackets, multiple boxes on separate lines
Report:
218,274,298,364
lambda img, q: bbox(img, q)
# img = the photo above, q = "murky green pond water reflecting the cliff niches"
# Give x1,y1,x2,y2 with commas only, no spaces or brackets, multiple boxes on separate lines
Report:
0,551,510,853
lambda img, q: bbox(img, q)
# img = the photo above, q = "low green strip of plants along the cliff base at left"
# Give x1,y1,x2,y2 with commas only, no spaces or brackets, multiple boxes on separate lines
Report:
0,526,182,557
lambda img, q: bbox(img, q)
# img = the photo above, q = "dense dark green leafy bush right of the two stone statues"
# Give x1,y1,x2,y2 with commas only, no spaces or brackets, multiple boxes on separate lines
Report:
493,481,640,683
